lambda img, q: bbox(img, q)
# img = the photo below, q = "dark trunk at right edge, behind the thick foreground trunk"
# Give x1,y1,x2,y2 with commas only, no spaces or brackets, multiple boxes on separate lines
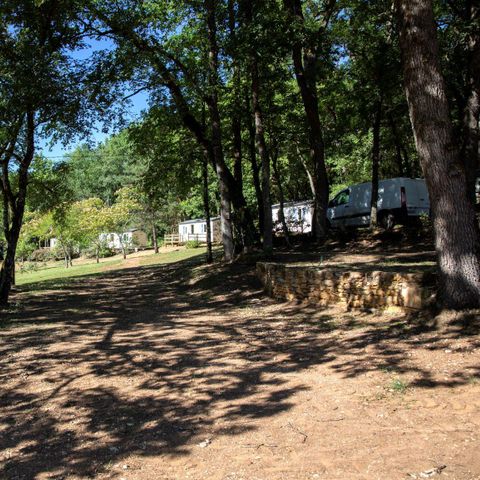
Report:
462,0,480,205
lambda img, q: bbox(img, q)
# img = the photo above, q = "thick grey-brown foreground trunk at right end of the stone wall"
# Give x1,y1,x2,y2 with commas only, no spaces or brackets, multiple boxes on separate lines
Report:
396,0,480,309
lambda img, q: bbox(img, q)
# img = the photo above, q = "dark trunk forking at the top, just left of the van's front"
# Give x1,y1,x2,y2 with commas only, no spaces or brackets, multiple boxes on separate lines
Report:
284,0,335,240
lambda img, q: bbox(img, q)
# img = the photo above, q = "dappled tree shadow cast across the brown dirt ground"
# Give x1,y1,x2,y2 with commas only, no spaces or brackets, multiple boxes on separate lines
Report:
0,253,480,479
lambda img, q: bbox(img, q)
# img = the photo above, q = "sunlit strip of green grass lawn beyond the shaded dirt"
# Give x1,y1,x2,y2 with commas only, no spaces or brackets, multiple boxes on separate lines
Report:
16,248,205,286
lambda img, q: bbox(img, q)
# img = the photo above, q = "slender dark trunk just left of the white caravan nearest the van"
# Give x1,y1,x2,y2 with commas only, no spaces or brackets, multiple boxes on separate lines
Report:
245,0,273,255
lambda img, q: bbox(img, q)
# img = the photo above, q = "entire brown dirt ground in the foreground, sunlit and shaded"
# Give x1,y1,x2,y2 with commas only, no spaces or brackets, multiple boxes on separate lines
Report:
0,253,480,480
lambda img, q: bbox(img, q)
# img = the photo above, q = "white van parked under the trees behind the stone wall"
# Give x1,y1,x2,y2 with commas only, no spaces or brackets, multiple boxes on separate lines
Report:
327,178,430,229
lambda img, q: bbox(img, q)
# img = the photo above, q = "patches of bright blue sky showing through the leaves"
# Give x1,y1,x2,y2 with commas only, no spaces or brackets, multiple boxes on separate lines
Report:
38,39,148,159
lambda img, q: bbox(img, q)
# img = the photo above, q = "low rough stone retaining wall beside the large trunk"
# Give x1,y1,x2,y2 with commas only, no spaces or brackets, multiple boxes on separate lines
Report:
257,262,432,309
